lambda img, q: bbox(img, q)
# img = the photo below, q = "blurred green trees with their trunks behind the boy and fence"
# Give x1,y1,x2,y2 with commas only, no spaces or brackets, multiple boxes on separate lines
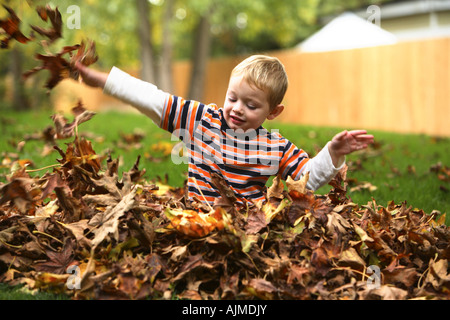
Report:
0,0,395,110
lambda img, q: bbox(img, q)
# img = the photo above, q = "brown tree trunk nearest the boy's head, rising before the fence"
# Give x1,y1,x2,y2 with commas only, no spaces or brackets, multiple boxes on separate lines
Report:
188,13,211,101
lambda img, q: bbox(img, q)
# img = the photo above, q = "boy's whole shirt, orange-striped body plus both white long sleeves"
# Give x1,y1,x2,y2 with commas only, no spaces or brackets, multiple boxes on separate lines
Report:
103,67,345,203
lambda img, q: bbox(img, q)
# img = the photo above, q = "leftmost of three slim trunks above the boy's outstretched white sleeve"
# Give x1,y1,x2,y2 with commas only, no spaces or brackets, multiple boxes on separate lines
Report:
136,0,157,84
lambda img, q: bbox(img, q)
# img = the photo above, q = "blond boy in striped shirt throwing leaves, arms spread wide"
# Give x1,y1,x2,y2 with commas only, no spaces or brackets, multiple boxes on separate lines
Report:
77,55,373,204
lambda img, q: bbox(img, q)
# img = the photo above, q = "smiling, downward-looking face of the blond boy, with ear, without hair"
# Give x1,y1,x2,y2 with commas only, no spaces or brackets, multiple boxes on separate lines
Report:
224,75,284,132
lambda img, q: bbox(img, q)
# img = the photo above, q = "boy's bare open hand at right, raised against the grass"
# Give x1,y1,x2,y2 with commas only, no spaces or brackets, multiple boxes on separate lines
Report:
329,130,374,166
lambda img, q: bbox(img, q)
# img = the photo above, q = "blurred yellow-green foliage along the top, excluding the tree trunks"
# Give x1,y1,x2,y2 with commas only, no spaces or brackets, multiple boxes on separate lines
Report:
0,0,400,71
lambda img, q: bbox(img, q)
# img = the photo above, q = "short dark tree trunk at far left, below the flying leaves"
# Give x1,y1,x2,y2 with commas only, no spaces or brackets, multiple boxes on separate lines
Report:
10,48,30,111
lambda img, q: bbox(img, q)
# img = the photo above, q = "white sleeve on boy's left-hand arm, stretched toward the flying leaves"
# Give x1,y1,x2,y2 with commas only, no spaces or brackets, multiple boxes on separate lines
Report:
103,67,169,126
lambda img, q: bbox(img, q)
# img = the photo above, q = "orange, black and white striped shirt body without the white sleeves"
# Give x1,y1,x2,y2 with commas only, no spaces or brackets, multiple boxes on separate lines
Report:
160,95,309,203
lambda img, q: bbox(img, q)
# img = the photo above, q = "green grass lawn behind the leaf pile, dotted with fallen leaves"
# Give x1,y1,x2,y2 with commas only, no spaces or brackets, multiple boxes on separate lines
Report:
0,107,450,224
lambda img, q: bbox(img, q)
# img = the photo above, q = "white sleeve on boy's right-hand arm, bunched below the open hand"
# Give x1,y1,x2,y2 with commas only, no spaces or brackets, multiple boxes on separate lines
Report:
303,142,345,191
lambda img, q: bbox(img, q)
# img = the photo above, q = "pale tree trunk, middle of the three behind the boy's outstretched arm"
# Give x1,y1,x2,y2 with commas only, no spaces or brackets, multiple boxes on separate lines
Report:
159,0,175,93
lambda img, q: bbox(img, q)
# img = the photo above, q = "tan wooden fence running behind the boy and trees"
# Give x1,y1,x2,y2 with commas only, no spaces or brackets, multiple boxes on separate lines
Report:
54,38,450,136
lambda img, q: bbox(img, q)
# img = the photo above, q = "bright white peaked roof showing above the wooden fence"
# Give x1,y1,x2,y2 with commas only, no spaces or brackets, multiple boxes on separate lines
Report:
297,12,397,52
